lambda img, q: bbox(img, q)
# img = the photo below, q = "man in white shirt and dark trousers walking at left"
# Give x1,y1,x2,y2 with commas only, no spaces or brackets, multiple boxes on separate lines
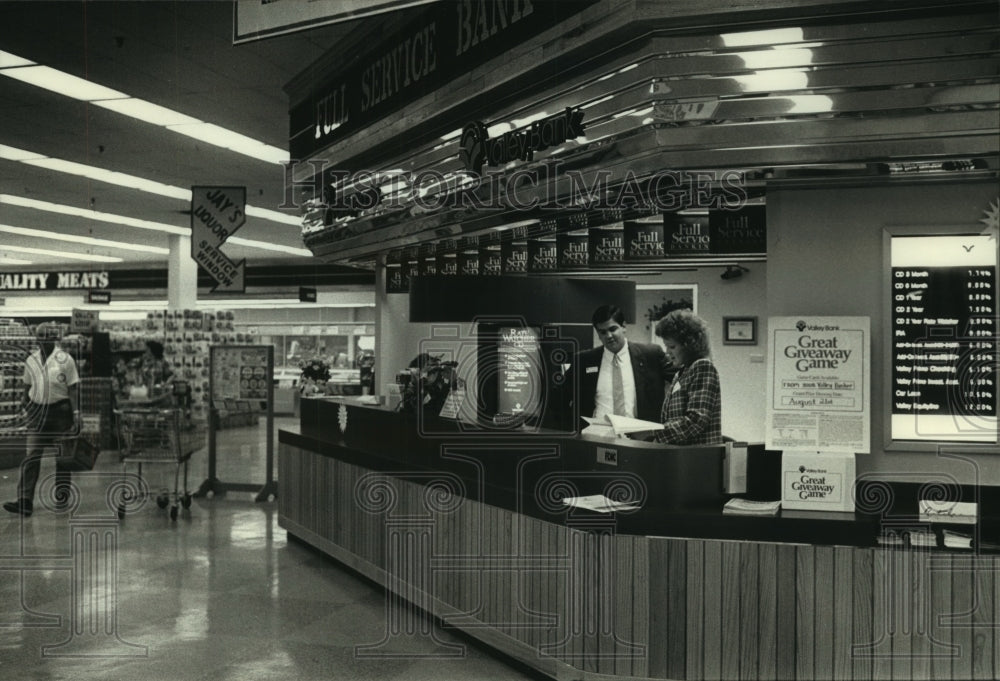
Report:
3,323,80,516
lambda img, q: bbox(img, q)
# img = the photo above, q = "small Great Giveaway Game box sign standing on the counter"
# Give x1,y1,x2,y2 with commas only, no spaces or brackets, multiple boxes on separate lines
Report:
781,452,855,511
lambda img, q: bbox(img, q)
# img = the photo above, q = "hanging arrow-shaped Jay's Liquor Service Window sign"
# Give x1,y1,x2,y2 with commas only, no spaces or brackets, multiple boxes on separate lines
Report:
191,187,247,293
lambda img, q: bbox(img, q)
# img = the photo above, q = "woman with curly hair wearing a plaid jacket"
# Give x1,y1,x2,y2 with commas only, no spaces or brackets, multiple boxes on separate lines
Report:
655,310,722,445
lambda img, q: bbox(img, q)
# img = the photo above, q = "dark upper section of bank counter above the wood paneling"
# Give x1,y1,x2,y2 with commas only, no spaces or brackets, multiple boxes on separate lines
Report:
279,400,880,546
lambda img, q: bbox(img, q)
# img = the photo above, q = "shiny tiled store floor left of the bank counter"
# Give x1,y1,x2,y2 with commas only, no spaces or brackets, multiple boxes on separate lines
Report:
0,418,537,681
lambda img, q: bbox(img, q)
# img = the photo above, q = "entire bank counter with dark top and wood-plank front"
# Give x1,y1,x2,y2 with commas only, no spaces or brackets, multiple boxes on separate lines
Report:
278,398,1000,679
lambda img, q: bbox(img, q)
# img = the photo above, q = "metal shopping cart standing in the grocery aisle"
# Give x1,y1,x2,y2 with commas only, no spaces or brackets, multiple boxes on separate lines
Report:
115,409,206,520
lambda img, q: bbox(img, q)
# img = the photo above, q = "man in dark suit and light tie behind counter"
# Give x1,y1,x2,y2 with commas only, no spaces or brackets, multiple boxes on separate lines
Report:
568,305,673,423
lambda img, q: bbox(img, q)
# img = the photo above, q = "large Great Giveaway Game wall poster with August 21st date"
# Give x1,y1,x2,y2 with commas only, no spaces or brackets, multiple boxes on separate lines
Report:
765,317,871,454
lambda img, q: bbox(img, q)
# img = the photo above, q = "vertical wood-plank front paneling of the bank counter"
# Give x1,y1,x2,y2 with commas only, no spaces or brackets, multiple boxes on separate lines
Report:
278,436,1000,681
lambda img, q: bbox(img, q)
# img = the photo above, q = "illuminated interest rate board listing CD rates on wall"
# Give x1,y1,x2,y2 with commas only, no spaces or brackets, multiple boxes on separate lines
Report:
888,235,1000,443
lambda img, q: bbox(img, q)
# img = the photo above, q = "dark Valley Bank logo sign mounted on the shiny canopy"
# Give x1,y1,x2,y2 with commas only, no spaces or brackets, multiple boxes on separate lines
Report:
458,107,584,173
